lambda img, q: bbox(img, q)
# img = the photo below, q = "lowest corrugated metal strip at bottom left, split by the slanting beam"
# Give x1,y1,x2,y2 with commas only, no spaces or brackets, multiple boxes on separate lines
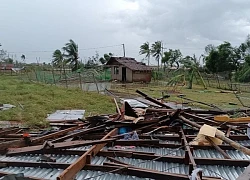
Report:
0,167,146,180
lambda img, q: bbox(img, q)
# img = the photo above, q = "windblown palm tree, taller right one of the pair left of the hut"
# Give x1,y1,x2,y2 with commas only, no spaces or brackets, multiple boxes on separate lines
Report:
62,39,79,71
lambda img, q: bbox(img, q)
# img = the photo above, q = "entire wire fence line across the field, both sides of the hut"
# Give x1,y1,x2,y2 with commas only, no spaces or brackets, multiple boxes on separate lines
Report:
0,66,250,92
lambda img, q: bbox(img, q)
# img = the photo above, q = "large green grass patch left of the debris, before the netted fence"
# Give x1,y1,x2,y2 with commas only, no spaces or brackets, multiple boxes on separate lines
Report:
0,76,115,127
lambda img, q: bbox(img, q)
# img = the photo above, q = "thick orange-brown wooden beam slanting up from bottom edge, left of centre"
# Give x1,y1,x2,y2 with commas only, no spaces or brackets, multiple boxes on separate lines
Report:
57,129,118,180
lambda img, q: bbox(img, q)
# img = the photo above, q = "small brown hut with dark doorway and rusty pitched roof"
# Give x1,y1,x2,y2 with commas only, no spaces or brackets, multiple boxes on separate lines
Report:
106,57,152,82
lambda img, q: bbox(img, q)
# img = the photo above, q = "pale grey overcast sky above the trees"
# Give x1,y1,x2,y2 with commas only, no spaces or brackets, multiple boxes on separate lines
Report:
0,0,250,63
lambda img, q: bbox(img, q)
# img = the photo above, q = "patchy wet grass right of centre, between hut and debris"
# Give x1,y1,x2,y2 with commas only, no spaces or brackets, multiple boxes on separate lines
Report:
112,85,250,110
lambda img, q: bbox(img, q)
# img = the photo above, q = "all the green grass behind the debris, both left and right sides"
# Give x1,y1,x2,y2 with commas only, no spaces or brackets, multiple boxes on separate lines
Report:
0,76,250,127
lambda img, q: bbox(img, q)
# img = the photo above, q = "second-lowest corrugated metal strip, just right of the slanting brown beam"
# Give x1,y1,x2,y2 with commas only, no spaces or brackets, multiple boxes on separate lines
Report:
91,156,188,174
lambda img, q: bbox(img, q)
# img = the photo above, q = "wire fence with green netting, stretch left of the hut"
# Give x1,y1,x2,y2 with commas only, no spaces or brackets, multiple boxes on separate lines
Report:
5,67,111,92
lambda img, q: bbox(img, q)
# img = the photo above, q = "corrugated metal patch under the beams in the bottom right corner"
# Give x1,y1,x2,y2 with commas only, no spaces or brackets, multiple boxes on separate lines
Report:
198,165,245,180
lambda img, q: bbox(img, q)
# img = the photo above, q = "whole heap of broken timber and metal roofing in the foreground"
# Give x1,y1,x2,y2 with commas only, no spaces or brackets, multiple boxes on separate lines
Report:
0,91,250,180
